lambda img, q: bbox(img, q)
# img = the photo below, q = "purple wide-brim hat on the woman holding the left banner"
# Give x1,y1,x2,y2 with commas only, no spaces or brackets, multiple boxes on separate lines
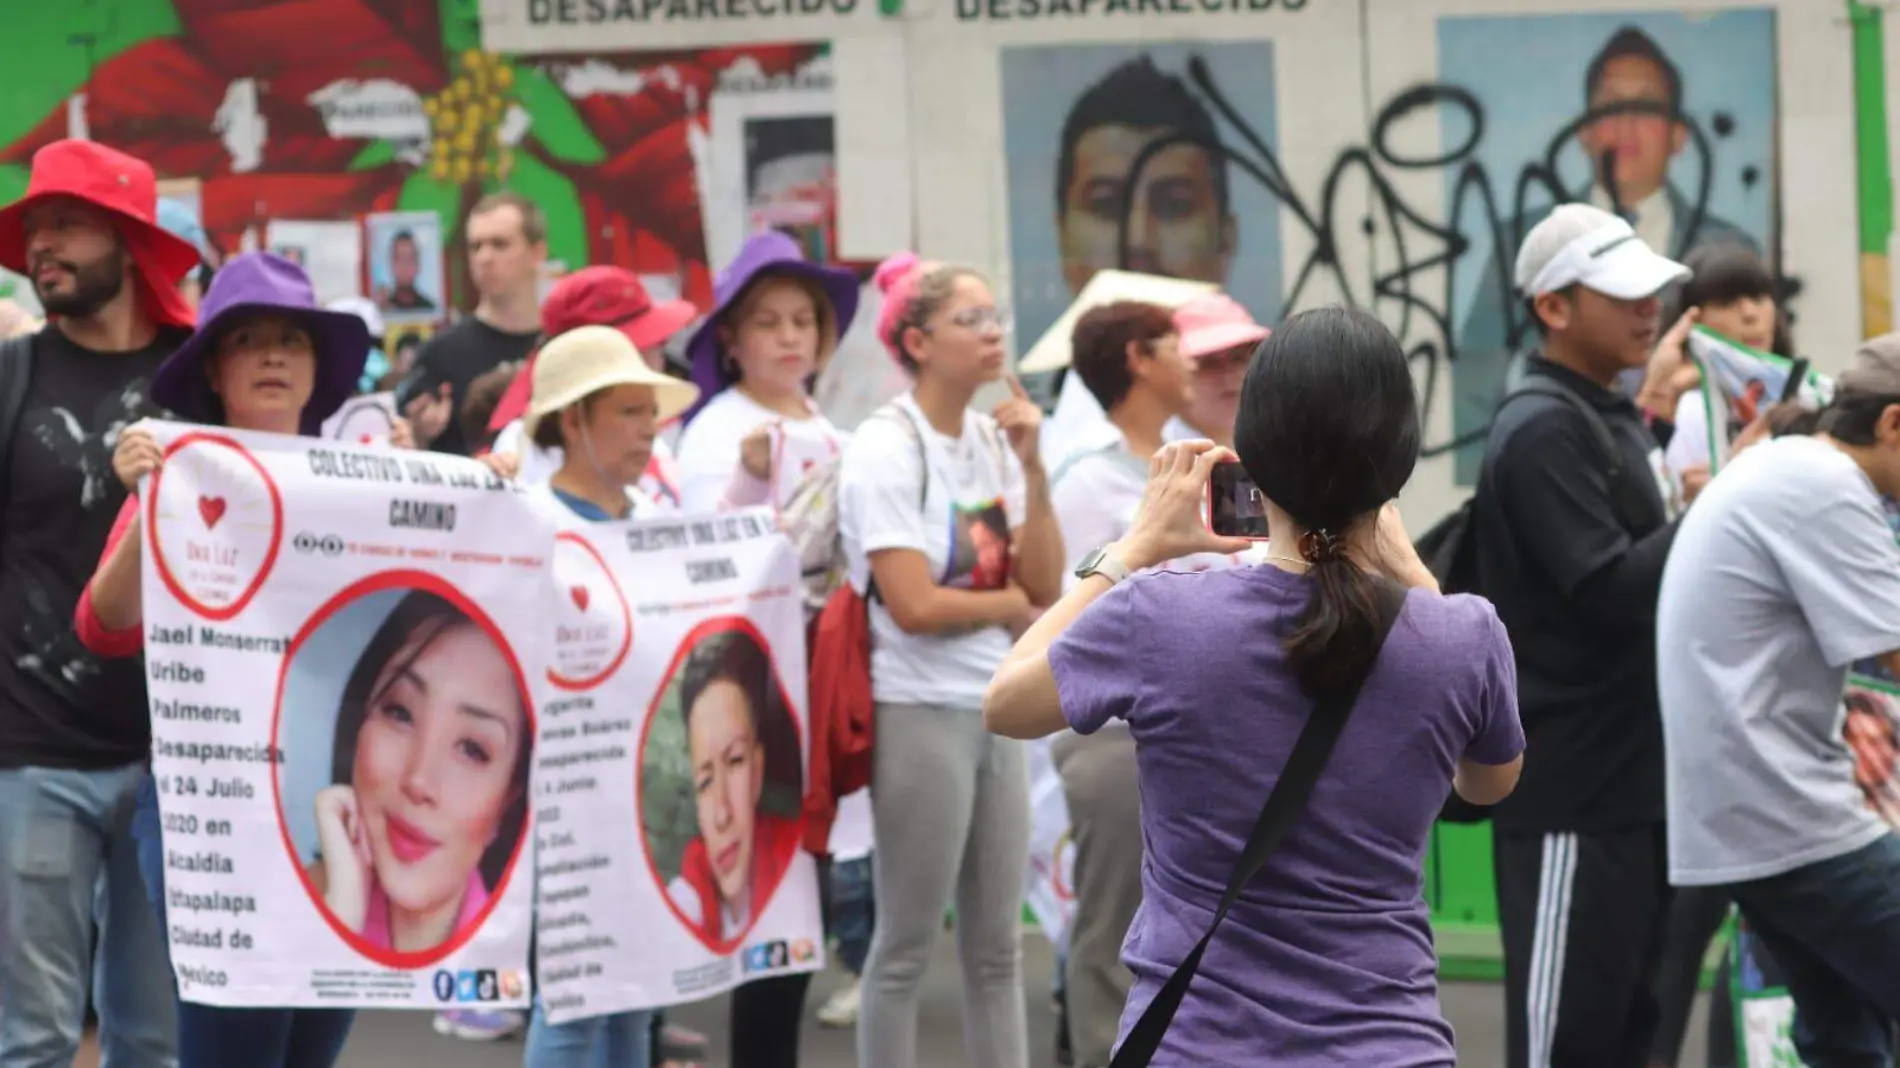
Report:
152,253,369,433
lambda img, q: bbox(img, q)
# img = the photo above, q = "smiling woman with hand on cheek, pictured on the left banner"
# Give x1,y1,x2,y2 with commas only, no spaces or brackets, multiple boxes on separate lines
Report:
306,589,532,954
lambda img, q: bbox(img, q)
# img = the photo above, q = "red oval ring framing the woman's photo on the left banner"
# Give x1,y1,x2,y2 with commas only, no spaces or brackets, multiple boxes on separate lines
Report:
270,570,540,969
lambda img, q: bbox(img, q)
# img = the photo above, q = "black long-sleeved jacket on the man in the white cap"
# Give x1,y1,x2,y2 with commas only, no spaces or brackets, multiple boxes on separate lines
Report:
1473,359,1676,830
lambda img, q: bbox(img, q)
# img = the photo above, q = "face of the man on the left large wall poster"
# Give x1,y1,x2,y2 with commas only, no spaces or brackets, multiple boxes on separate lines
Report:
1058,124,1233,293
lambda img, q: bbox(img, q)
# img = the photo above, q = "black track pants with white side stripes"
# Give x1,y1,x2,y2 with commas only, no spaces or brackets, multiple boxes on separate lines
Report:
1492,823,1670,1068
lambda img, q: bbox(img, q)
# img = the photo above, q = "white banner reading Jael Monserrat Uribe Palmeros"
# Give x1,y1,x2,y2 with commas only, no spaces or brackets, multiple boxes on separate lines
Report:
141,422,555,1009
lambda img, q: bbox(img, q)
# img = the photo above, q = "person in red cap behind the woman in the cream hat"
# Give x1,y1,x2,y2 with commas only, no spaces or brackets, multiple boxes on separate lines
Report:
488,266,699,507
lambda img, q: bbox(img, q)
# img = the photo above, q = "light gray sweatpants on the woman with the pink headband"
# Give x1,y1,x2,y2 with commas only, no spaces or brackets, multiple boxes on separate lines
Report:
857,705,1030,1068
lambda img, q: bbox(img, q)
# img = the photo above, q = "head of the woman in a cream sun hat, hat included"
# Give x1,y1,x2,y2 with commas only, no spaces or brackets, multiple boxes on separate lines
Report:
523,327,699,521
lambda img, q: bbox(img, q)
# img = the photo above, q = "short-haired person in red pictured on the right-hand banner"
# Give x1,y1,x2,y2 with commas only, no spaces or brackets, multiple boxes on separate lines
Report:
650,625,800,952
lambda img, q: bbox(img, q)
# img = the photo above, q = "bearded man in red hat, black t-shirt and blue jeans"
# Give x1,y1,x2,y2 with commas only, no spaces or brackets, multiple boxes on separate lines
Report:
0,141,198,1068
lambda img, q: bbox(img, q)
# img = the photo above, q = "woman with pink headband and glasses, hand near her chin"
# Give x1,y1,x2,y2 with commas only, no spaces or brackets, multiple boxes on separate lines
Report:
838,253,1064,1068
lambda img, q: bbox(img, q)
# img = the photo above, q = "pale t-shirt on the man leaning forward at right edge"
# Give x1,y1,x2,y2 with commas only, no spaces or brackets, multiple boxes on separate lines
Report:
1657,437,1900,886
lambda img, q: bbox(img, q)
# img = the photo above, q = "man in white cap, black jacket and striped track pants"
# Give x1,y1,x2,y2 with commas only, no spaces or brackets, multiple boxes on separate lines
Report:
1473,203,1689,1068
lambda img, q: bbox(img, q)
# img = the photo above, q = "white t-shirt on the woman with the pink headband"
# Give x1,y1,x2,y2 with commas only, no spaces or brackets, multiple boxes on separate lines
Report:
838,393,1028,709
